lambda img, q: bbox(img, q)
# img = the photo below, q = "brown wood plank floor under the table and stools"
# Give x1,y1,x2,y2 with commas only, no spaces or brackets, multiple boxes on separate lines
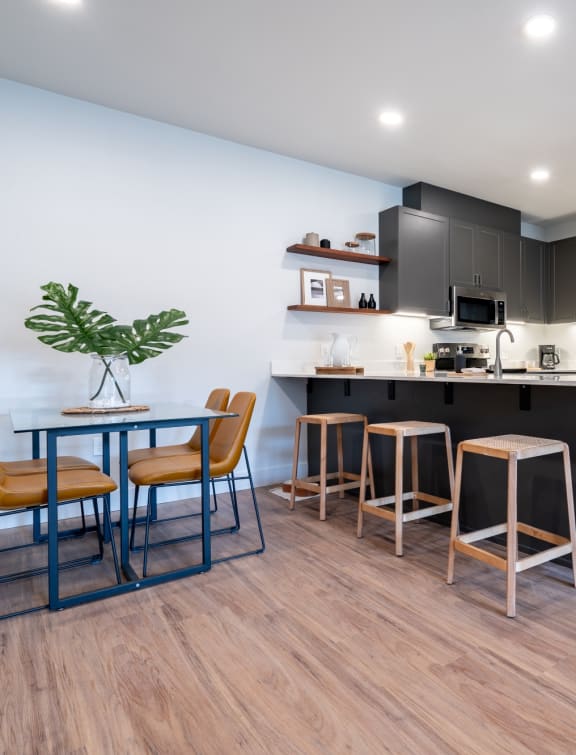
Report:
0,489,576,755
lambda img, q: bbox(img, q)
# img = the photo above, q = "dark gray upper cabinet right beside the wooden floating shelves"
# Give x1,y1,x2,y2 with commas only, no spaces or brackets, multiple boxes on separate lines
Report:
379,207,450,315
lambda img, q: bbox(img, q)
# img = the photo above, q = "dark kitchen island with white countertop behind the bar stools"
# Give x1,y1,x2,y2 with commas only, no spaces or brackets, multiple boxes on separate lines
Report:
272,363,576,564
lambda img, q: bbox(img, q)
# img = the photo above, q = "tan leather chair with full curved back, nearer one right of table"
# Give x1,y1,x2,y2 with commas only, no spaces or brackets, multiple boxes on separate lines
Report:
129,392,265,576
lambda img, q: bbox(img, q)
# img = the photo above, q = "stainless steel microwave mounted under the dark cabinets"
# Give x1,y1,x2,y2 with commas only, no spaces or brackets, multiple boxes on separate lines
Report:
430,286,506,330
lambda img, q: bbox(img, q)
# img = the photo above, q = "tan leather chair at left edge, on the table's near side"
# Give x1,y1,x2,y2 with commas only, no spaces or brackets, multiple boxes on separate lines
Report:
0,464,121,618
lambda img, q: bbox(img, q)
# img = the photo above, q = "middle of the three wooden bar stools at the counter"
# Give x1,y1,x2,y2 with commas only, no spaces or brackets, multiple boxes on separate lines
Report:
357,420,454,556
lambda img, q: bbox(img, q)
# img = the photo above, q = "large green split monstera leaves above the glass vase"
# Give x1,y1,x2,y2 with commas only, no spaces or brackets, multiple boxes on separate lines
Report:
24,282,188,364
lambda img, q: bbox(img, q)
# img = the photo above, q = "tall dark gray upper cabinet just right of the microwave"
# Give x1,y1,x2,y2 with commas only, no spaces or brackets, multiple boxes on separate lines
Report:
502,233,546,322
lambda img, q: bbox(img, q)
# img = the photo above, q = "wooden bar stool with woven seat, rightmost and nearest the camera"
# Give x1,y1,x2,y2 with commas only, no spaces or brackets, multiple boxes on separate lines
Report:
447,435,576,617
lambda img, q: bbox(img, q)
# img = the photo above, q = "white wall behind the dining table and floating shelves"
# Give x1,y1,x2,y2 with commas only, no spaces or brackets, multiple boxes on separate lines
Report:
0,80,572,520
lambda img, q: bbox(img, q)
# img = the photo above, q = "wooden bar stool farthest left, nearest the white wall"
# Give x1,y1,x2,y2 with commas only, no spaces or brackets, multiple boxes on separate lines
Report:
289,412,374,521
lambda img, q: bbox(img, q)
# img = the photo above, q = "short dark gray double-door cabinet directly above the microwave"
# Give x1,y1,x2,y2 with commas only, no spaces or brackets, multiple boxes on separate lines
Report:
450,218,503,288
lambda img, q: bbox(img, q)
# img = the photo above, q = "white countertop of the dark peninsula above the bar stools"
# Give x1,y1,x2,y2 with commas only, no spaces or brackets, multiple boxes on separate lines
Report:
270,360,576,387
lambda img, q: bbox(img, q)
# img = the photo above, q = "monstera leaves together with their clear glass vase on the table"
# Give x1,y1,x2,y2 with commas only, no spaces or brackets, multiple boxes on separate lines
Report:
24,282,188,406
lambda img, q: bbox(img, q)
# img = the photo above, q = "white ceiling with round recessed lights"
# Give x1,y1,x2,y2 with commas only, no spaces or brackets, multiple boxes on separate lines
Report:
0,0,576,222
